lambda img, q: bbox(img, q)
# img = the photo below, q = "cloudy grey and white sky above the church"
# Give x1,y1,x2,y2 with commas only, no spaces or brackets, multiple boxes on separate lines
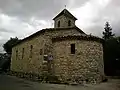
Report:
0,0,120,53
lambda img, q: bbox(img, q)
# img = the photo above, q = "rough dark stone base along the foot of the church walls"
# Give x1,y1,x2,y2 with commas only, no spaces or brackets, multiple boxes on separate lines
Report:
8,71,105,85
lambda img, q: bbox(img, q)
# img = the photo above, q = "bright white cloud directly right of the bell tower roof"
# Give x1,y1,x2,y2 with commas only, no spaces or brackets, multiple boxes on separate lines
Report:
72,0,111,32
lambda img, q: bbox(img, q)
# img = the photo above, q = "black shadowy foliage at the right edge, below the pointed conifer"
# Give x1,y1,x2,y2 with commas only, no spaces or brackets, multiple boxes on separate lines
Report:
104,37,120,75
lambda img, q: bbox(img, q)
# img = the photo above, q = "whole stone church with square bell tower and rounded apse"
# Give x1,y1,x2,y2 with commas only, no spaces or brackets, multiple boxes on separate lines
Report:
11,9,104,83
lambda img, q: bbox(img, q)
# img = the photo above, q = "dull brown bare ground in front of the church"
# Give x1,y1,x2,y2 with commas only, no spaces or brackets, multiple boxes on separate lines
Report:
0,75,120,90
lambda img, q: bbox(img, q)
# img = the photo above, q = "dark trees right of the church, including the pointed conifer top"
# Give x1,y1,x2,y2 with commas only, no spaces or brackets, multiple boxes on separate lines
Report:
103,22,120,76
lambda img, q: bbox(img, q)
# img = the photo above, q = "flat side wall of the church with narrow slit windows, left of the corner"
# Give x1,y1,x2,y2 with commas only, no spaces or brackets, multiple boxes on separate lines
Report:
11,35,45,73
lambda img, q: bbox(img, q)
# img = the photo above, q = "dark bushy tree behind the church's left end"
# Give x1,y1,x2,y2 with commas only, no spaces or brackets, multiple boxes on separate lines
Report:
3,37,20,54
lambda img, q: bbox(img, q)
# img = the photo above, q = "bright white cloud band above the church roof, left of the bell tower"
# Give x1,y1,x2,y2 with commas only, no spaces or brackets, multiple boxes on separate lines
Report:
0,13,52,52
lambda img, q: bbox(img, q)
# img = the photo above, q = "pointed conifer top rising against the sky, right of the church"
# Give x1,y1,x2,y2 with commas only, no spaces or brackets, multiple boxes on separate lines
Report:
103,22,115,40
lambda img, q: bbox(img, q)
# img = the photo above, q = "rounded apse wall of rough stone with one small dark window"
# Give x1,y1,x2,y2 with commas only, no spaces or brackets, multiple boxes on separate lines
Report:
53,40,104,83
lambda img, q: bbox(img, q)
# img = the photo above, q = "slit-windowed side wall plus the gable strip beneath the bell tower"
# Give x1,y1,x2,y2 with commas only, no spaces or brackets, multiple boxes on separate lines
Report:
11,29,80,74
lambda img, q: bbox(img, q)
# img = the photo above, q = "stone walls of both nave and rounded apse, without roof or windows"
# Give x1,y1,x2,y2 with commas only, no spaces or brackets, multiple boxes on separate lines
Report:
11,29,104,83
